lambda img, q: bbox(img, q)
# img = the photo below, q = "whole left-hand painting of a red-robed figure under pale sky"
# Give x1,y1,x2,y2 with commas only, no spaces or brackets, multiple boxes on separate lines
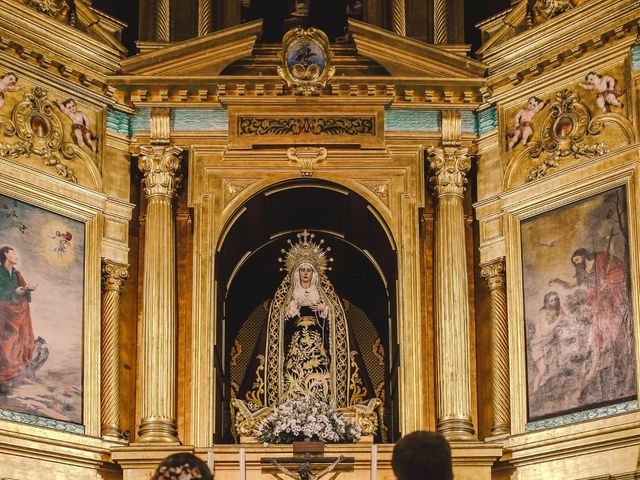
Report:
0,195,85,424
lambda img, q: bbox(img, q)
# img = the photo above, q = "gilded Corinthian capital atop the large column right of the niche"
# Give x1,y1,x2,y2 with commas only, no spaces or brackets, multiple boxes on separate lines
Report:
427,147,471,196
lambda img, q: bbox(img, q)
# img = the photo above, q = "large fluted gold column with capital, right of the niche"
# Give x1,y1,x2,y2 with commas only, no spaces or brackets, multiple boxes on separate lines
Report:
428,146,474,440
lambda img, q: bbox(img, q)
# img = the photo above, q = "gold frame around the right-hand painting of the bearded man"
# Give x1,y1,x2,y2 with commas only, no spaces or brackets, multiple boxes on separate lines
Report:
504,156,640,434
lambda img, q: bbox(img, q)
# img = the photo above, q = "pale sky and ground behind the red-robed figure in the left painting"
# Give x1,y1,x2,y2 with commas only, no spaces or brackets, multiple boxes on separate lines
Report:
0,195,85,423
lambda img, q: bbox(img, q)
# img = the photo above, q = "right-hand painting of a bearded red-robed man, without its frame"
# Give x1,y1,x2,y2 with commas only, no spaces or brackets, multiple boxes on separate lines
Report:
521,187,636,420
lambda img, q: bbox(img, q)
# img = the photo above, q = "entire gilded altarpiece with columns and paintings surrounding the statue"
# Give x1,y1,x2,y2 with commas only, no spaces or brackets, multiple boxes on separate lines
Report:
0,0,640,480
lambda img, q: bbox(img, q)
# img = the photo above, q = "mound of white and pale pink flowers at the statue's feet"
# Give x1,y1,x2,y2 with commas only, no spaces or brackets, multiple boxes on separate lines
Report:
257,397,360,443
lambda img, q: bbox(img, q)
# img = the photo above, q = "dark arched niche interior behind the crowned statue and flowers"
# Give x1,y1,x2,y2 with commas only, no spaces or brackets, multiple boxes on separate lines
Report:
215,181,398,442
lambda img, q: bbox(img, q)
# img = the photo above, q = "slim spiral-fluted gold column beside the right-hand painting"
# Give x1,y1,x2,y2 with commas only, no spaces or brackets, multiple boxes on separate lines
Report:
480,259,511,435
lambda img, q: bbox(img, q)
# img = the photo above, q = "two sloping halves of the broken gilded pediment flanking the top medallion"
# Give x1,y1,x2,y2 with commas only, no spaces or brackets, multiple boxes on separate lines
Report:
117,20,485,78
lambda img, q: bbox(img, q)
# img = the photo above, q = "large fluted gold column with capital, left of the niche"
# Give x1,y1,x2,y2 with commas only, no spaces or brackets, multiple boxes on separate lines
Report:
138,145,182,443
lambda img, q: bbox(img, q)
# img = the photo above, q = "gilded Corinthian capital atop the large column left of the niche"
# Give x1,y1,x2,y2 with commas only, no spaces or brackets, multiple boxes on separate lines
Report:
138,145,182,198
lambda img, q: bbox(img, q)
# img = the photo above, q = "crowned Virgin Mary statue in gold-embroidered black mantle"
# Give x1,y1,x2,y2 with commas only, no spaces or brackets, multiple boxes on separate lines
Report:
265,230,350,407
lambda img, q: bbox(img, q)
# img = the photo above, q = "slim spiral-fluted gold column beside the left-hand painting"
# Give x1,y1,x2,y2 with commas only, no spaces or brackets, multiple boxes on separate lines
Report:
100,260,129,437
